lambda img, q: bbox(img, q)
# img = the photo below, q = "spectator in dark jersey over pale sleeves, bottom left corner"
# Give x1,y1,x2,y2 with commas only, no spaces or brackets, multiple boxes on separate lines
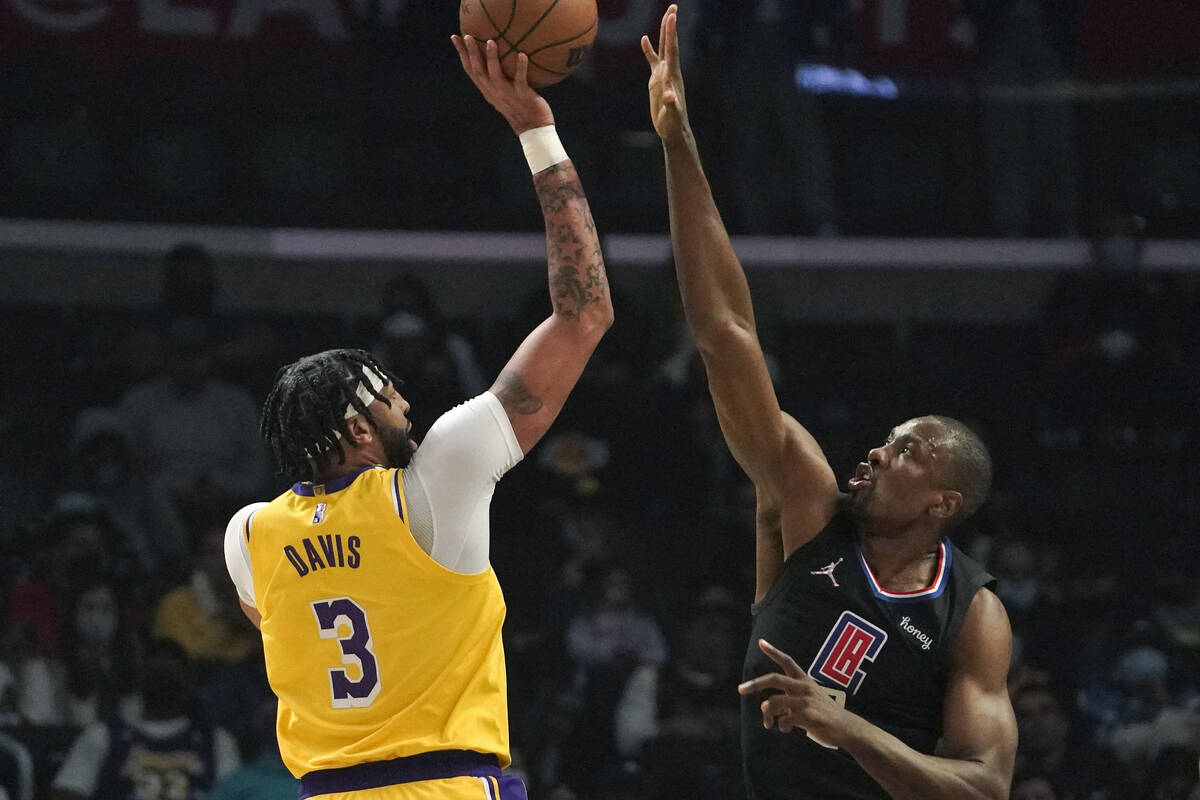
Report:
50,639,239,800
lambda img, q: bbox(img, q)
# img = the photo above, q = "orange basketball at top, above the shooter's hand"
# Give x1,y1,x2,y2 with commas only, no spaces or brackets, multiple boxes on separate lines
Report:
458,0,596,88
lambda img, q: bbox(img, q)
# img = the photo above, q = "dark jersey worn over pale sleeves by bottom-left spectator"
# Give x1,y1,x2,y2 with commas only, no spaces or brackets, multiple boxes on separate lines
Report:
95,721,216,800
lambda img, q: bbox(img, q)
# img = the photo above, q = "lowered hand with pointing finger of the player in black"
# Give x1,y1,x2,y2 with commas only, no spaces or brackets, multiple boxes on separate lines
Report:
738,639,848,747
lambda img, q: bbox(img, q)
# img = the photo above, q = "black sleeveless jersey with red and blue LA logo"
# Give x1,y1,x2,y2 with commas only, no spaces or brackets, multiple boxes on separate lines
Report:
742,511,992,800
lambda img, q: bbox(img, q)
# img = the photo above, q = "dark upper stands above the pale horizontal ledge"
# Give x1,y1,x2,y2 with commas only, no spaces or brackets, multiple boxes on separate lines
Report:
0,0,1200,237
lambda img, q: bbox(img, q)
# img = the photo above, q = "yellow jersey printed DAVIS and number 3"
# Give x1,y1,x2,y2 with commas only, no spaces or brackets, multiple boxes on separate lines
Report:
244,468,510,777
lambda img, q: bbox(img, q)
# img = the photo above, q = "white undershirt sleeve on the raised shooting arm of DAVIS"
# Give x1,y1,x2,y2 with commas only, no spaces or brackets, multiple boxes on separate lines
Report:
404,392,524,575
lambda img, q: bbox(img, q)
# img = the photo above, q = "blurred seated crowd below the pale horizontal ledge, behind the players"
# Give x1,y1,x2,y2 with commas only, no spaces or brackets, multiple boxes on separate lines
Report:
0,245,1200,800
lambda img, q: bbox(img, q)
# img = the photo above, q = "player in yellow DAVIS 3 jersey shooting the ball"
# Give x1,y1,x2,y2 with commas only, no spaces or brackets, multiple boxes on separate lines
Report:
226,37,612,800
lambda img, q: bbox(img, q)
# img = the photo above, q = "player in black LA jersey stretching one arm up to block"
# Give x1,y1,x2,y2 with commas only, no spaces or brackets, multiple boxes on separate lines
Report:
642,6,1016,800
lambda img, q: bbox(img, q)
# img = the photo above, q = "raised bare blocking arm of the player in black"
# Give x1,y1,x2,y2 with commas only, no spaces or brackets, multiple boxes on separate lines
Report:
642,6,838,553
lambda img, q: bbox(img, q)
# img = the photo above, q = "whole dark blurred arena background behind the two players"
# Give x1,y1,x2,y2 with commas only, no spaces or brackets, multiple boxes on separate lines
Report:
0,0,1200,800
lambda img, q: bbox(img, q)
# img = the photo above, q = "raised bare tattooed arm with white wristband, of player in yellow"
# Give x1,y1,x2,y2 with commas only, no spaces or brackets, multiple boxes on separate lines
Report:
451,36,613,452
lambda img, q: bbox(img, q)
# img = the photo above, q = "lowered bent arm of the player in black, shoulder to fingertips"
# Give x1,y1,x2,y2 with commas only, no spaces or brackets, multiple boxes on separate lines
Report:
738,589,1016,800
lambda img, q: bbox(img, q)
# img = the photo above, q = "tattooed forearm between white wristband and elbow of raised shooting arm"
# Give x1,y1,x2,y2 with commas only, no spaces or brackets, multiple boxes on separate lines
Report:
534,162,608,319
